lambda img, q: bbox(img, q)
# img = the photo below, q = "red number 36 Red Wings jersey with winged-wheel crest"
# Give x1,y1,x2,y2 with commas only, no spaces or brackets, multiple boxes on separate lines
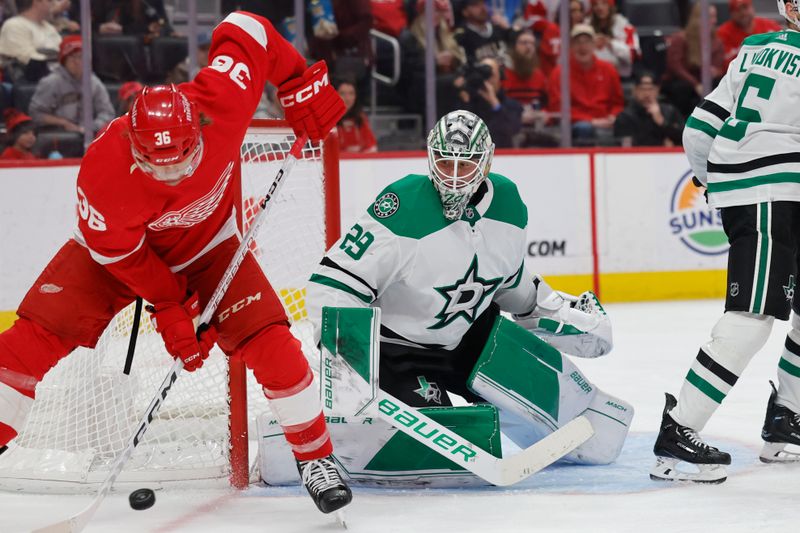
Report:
75,11,306,302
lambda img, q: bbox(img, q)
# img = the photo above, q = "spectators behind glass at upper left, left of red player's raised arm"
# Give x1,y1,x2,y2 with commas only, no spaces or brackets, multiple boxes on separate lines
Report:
0,0,183,159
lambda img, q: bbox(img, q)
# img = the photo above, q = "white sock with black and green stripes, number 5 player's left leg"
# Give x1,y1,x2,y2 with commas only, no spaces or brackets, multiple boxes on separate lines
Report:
671,311,775,432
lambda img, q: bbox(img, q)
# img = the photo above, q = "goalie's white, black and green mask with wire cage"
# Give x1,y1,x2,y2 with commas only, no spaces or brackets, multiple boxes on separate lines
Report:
428,110,494,220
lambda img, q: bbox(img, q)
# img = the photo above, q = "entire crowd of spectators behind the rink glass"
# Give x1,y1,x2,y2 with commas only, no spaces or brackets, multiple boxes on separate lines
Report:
0,0,781,158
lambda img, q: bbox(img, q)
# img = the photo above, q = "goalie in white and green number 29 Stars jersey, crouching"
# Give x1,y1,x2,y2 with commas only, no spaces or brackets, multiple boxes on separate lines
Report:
290,111,633,483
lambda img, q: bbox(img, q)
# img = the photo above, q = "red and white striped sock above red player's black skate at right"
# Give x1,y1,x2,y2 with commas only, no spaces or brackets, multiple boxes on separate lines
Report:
242,324,333,461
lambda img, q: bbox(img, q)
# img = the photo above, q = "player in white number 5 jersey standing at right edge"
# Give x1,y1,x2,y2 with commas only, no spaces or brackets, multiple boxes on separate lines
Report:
650,0,800,483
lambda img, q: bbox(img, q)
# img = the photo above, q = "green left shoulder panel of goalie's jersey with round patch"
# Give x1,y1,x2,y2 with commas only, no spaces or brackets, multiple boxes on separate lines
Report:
367,174,452,239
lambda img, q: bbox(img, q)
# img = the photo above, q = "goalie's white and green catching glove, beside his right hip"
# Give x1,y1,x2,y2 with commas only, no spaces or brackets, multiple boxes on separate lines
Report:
514,276,613,358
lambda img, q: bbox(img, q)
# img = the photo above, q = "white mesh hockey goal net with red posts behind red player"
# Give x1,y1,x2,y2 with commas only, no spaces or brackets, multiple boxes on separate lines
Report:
0,120,339,492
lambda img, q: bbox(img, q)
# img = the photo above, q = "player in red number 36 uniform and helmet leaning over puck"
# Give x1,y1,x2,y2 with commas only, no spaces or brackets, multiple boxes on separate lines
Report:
0,12,351,512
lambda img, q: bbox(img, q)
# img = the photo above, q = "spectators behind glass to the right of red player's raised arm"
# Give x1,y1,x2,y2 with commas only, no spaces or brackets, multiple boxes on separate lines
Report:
258,0,781,148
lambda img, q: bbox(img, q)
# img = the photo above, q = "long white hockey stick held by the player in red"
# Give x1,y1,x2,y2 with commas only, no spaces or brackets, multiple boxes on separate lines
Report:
33,135,308,533
